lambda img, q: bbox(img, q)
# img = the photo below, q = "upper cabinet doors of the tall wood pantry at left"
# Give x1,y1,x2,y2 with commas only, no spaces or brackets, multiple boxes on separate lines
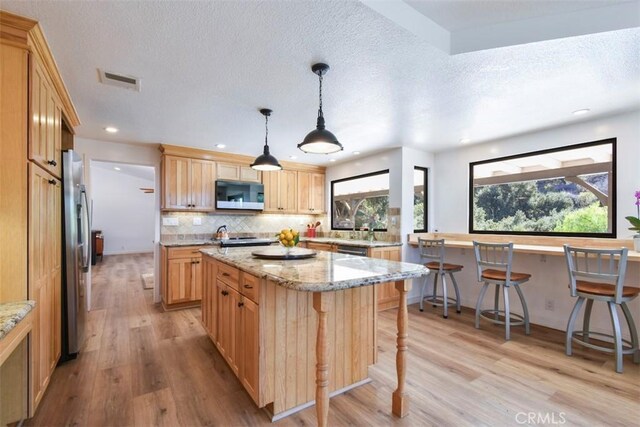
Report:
29,56,62,177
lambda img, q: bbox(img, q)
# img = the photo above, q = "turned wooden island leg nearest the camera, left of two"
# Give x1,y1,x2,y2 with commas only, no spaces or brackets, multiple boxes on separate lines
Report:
313,292,335,427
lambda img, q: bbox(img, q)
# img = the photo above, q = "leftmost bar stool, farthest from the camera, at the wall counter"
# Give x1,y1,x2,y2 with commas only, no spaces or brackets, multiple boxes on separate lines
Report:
418,238,462,319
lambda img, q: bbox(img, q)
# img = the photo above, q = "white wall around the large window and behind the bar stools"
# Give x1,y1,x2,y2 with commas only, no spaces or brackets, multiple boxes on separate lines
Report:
428,111,640,340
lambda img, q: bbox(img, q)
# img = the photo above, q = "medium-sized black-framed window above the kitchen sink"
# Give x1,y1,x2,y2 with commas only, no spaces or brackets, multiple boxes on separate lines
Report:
331,170,389,231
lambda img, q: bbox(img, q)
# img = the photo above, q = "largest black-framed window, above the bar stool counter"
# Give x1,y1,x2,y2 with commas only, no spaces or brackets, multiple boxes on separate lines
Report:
469,138,616,237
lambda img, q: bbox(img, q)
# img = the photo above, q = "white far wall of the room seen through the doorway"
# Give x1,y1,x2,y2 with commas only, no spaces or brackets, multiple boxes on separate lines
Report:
91,166,155,255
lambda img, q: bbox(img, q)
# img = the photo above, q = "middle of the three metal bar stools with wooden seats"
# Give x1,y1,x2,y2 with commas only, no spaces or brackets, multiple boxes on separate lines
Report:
473,241,531,341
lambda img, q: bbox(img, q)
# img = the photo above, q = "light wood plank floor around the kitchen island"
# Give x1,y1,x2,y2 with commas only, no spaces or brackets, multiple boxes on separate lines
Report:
27,255,640,426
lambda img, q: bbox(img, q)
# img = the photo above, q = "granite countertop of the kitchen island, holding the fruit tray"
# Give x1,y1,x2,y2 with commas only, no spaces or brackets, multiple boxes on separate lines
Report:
200,247,429,292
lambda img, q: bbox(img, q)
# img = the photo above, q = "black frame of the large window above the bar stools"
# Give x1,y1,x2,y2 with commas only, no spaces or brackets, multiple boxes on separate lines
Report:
467,138,618,239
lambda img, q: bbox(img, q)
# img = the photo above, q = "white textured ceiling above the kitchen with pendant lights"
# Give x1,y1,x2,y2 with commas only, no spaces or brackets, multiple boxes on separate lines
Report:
2,0,640,164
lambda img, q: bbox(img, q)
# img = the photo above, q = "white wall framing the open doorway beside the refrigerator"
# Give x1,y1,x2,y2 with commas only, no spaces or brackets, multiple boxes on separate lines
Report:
74,137,160,309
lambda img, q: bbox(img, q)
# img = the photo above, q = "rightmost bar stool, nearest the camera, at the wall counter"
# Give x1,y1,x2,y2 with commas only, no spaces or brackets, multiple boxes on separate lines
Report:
564,245,640,373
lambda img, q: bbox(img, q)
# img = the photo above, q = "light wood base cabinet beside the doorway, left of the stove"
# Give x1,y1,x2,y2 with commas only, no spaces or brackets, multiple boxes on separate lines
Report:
160,246,202,310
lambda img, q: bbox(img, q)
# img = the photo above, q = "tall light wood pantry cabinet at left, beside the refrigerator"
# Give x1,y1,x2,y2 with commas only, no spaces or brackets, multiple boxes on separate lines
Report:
0,11,79,416
